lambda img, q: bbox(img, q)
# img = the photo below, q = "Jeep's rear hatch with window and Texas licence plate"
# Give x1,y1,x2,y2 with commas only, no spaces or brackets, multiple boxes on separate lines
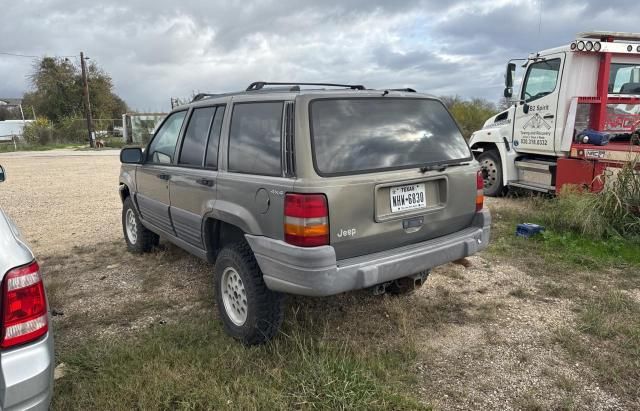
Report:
296,95,478,260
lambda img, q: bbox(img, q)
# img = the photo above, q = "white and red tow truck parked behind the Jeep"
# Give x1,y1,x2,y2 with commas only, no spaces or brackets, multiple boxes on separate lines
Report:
469,32,640,196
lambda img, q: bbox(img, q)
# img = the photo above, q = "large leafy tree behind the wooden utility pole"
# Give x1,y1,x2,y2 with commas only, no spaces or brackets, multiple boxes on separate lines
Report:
23,57,127,124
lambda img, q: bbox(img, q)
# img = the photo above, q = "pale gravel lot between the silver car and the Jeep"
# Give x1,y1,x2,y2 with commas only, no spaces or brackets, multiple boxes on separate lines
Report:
0,150,122,256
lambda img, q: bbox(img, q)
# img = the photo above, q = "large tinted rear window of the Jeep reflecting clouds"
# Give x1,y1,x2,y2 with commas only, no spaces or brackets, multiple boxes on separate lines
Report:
309,97,471,175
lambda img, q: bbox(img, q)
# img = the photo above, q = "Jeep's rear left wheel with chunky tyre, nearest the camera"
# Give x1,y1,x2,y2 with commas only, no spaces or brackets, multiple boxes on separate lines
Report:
215,243,284,345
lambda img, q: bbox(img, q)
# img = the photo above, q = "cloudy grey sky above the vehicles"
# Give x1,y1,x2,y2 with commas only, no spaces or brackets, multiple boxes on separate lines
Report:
0,0,640,111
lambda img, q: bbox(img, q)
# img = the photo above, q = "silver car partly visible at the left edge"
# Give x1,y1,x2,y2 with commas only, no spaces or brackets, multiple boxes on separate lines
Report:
0,166,54,410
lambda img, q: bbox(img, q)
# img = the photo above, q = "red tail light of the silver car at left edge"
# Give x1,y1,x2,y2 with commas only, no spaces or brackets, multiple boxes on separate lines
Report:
0,261,49,348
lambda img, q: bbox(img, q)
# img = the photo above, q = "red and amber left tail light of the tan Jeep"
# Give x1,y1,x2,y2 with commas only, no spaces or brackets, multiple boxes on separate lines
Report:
284,193,329,247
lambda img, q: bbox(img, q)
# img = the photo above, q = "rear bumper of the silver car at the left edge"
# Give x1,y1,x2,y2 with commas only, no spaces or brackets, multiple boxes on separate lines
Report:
0,332,54,410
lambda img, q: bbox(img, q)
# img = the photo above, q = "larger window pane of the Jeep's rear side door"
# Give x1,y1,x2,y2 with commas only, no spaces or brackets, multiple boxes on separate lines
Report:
178,107,216,166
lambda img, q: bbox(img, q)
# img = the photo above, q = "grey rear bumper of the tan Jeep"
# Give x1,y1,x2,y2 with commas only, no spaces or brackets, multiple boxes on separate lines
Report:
246,209,491,296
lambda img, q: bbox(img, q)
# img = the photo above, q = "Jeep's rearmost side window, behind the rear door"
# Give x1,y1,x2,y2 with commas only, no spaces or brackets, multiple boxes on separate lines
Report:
229,101,284,176
